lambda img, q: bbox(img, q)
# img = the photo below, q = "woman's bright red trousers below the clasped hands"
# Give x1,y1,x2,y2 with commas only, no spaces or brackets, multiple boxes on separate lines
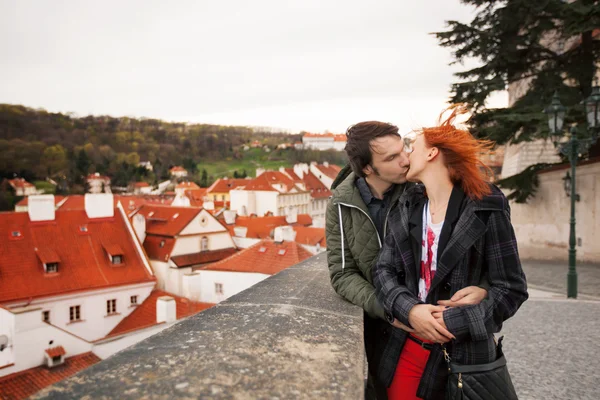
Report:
388,339,430,400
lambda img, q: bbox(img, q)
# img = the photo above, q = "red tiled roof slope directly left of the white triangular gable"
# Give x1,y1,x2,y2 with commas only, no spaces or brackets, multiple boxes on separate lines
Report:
138,204,202,236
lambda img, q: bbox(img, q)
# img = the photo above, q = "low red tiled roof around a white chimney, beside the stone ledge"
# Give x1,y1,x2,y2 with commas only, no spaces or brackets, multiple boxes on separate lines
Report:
107,290,214,337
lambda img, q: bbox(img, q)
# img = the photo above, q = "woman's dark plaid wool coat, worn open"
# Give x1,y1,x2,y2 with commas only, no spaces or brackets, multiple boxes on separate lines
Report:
373,185,528,400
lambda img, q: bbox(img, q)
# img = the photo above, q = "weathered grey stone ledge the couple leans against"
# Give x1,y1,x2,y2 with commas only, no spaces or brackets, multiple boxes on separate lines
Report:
35,254,365,399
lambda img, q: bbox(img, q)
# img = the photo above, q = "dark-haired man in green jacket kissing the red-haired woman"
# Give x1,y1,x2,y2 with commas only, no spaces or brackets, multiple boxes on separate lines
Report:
325,121,487,399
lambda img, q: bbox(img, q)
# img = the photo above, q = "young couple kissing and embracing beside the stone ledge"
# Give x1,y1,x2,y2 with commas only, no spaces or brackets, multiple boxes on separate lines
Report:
326,109,528,400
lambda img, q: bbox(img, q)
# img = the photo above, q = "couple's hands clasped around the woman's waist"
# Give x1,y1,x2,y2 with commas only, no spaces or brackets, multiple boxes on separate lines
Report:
392,286,487,343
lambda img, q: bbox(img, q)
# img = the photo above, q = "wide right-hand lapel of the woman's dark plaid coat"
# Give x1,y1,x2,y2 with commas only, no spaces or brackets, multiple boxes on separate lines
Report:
430,191,487,293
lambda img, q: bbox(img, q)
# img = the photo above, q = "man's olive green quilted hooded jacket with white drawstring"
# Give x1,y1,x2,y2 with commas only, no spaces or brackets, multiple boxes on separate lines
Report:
325,166,406,319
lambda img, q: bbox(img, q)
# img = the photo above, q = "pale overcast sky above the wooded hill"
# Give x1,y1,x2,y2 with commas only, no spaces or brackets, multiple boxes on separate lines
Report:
0,0,506,132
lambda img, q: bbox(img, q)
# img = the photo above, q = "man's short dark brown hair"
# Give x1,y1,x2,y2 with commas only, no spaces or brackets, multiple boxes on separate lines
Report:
344,121,400,178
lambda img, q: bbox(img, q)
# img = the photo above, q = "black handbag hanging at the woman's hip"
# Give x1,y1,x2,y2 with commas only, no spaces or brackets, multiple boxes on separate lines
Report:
442,336,518,400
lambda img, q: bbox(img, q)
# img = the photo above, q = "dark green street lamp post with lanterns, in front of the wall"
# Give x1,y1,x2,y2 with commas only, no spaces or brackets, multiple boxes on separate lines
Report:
544,86,600,299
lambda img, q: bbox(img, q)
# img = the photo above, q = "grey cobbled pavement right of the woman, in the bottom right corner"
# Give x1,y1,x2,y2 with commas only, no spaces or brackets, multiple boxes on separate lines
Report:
502,288,600,400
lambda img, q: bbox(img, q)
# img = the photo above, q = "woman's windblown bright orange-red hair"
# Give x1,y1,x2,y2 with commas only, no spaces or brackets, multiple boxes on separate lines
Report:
422,106,494,200
